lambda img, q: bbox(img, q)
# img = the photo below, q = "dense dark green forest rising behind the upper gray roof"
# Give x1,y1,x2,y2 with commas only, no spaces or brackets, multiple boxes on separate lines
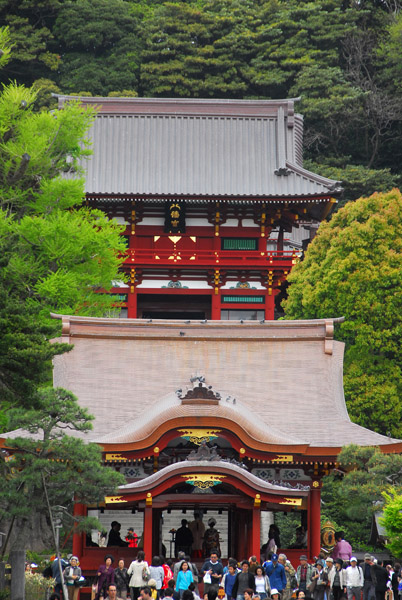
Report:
0,0,402,204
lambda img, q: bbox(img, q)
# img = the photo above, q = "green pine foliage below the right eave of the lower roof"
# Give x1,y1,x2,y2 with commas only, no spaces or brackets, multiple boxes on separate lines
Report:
322,444,402,546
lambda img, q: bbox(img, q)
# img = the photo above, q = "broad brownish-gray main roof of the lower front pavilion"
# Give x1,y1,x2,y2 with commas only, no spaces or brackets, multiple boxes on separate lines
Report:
39,317,399,448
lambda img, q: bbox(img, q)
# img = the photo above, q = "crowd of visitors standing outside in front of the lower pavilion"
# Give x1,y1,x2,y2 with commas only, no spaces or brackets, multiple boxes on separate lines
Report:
76,547,402,600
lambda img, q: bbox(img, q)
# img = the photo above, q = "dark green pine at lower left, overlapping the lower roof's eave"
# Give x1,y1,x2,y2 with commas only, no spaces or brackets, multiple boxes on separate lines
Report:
0,388,125,598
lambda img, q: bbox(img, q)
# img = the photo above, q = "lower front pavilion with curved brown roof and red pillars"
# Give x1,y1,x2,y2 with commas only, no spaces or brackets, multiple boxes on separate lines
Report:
54,315,402,572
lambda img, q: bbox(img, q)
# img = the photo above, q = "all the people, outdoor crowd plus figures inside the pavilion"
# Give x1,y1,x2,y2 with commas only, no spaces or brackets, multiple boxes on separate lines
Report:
45,515,402,600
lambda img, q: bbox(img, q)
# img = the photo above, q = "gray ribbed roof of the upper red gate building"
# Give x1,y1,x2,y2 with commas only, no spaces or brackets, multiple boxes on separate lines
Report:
59,96,339,198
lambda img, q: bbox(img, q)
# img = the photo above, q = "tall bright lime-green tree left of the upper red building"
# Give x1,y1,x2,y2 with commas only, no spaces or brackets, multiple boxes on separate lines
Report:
0,77,124,410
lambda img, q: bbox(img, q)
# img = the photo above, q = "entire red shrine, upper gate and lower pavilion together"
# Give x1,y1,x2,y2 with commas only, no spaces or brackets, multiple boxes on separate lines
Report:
1,96,402,597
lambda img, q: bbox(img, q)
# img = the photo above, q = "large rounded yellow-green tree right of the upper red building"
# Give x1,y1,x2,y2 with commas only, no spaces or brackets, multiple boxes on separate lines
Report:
284,190,402,437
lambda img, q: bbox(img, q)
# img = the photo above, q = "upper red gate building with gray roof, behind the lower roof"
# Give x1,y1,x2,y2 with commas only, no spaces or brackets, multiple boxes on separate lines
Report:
59,96,340,319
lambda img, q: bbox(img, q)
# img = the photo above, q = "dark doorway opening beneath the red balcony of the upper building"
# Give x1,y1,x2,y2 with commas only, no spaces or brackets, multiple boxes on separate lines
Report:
137,294,211,319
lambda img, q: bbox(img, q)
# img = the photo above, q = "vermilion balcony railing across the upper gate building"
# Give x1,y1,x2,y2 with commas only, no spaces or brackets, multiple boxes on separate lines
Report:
124,249,302,269
